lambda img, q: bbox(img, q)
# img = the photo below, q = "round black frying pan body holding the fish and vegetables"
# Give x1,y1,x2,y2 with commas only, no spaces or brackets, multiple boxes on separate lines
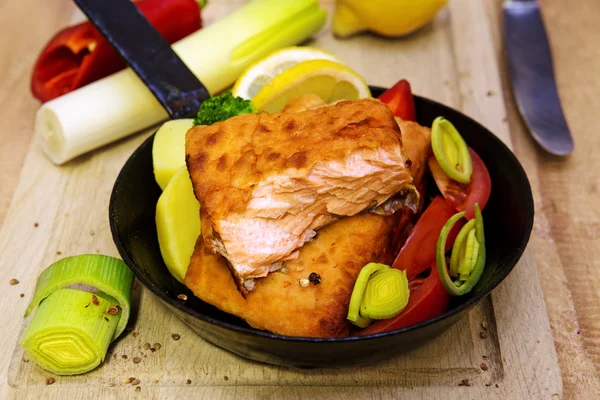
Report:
77,0,534,367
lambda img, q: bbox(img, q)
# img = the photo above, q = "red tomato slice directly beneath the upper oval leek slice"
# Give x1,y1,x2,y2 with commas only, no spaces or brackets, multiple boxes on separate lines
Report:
428,148,492,219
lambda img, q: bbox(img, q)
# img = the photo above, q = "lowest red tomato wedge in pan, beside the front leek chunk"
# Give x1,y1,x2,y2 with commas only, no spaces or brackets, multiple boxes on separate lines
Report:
357,265,450,336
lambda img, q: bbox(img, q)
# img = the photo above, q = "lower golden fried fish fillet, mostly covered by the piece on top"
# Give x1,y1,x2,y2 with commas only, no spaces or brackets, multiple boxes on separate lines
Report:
184,120,430,337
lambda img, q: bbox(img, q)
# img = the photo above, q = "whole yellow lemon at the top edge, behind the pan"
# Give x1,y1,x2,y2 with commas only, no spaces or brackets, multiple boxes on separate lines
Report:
332,0,448,37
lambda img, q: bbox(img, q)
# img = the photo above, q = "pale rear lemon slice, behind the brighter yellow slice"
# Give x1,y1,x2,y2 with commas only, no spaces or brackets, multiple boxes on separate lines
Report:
231,46,340,100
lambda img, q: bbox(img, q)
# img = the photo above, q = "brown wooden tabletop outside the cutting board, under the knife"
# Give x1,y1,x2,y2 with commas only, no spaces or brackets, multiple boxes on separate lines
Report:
0,0,600,399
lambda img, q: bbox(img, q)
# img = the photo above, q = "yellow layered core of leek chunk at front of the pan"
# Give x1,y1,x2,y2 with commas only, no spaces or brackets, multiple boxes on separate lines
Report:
360,268,410,319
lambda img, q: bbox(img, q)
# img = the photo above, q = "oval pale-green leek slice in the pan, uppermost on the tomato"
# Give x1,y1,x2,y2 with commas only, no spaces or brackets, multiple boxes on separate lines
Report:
431,117,473,183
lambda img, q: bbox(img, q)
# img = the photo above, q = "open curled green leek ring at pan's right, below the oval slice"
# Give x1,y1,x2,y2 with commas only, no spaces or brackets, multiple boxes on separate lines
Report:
436,204,486,296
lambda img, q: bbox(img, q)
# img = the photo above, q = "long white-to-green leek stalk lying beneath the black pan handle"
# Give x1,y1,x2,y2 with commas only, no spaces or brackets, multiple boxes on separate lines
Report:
35,0,326,164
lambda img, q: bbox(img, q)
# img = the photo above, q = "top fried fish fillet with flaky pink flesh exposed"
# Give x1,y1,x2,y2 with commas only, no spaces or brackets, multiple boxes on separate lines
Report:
186,99,418,294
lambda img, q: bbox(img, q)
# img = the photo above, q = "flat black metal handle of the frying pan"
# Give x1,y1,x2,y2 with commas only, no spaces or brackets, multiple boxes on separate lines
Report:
75,0,210,118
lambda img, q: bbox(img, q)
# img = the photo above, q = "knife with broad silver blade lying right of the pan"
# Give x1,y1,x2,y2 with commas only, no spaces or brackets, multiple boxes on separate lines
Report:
503,0,573,156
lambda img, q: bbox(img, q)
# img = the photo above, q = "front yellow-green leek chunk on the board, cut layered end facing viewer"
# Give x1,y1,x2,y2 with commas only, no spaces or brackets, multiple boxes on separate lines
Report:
21,289,122,375
